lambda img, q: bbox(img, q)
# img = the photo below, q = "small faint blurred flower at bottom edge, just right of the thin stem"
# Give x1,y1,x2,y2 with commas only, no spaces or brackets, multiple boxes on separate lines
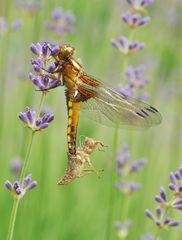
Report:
115,219,132,239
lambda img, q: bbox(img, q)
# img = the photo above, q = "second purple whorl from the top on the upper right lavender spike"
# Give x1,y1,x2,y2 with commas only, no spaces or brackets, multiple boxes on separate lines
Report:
122,12,150,28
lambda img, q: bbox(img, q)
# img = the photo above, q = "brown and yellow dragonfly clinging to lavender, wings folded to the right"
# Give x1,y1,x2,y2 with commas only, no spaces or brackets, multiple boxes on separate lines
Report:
46,44,162,155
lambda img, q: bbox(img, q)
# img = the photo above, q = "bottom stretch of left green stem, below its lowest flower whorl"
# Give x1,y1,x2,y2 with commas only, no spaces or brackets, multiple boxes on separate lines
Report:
7,198,20,240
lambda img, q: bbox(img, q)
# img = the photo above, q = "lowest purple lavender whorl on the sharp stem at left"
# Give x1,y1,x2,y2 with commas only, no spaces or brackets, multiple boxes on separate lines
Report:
5,174,37,198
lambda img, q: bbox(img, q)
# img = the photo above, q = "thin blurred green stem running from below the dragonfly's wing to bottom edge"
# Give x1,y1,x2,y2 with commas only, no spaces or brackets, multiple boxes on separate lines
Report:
105,126,118,240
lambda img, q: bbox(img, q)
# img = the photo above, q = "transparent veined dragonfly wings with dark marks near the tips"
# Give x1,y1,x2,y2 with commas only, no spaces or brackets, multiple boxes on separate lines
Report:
78,80,162,128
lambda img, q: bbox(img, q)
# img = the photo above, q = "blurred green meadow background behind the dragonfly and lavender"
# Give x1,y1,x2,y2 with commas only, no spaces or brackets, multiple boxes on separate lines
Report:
0,0,182,240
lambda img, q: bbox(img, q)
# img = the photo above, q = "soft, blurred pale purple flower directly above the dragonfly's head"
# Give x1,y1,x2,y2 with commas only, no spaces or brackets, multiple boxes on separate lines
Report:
45,8,75,36
